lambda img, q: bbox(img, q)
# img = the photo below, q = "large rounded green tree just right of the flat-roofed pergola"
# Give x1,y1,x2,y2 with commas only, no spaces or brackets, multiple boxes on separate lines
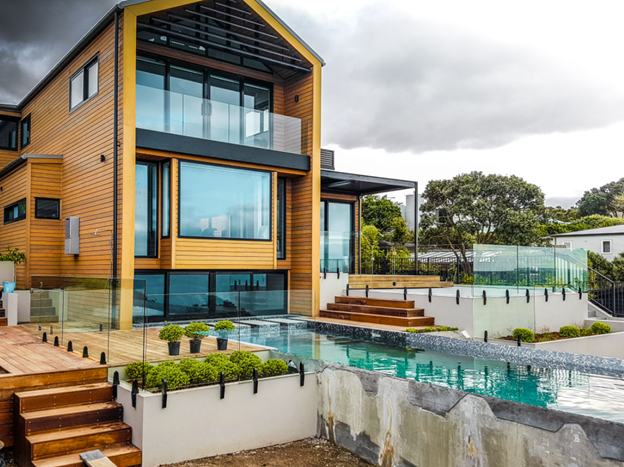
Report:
421,172,544,262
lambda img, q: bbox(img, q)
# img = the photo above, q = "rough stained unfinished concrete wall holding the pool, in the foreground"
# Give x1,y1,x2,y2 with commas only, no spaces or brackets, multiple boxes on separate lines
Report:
318,364,624,467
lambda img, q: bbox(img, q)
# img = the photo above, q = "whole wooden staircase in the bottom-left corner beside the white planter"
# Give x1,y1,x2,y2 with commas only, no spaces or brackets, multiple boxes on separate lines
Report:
15,381,141,467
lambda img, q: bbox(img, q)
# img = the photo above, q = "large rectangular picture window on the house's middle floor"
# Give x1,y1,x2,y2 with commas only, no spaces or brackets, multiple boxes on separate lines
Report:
179,162,271,240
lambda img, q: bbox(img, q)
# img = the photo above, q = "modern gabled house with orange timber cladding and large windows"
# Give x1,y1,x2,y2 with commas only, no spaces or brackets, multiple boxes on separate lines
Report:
0,0,417,328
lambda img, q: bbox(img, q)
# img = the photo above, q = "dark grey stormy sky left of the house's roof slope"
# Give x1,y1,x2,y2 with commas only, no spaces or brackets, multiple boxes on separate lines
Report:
0,0,118,104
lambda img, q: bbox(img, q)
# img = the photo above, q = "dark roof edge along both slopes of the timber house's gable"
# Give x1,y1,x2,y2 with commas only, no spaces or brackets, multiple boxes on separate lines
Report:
0,0,325,112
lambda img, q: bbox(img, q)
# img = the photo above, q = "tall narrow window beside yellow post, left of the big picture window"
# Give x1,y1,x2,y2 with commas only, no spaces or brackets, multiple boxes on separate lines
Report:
134,162,158,257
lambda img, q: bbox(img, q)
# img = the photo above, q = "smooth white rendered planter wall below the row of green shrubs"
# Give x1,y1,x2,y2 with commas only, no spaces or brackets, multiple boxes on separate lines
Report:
118,373,318,467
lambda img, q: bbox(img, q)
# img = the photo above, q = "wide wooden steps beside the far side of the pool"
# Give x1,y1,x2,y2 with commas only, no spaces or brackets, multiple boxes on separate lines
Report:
320,297,435,328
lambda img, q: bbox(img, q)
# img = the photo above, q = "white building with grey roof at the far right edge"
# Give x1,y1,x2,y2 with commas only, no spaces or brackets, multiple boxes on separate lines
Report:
552,225,624,261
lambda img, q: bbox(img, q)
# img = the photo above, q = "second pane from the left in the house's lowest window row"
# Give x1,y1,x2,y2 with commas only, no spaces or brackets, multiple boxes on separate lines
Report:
169,274,210,315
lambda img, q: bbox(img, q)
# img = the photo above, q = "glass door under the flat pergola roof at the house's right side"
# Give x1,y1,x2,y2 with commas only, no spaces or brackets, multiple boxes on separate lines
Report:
321,200,355,272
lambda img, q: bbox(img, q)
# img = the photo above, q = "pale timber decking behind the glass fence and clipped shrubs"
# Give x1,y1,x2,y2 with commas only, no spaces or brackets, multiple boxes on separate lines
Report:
19,325,264,366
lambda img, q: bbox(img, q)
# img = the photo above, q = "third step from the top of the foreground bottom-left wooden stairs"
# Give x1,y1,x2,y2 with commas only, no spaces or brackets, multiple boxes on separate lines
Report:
26,422,132,460
